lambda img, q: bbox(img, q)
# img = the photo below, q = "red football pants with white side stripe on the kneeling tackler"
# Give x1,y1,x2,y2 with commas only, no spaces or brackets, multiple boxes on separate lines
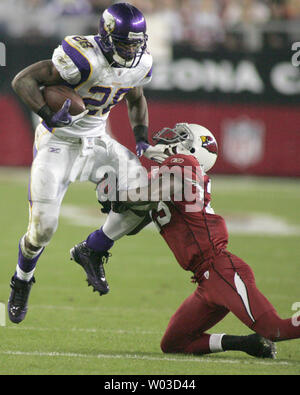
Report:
161,252,300,354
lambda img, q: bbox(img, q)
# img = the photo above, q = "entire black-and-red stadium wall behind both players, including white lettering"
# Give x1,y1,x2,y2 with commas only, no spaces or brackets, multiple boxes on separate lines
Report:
0,38,300,177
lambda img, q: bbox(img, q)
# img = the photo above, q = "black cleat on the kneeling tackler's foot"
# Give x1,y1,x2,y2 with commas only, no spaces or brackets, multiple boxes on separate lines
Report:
243,334,277,359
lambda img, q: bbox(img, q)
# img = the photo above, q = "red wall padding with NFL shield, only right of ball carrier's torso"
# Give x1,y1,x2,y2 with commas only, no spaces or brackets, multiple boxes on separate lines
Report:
110,101,300,177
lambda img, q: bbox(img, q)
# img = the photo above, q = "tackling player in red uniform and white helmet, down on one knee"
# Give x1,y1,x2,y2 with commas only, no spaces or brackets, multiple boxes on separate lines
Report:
72,124,300,358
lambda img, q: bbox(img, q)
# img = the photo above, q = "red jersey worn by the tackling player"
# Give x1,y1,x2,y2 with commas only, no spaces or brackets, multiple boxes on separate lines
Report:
152,154,228,279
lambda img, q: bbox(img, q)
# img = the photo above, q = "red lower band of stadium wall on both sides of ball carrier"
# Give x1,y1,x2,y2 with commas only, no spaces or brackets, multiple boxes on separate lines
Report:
0,96,300,177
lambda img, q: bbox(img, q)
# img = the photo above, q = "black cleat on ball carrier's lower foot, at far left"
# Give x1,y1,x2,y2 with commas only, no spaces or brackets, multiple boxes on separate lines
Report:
7,276,35,324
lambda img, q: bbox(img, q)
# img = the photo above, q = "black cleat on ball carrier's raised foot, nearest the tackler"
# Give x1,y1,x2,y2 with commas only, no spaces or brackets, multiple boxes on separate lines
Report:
70,241,111,296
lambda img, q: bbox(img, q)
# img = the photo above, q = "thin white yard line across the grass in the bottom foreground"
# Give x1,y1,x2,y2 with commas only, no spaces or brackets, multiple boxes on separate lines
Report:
0,350,300,367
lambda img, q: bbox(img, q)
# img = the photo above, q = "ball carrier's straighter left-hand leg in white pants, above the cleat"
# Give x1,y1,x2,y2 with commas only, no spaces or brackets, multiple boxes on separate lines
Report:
17,126,72,280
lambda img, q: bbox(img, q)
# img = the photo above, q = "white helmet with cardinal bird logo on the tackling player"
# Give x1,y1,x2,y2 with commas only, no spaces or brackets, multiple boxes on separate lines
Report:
150,123,218,172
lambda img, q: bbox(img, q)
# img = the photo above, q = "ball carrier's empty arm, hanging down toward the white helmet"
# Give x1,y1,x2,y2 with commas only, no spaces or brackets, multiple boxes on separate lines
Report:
125,86,149,156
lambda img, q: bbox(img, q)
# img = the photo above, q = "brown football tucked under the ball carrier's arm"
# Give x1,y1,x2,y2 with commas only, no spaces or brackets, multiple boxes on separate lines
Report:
42,85,85,115
